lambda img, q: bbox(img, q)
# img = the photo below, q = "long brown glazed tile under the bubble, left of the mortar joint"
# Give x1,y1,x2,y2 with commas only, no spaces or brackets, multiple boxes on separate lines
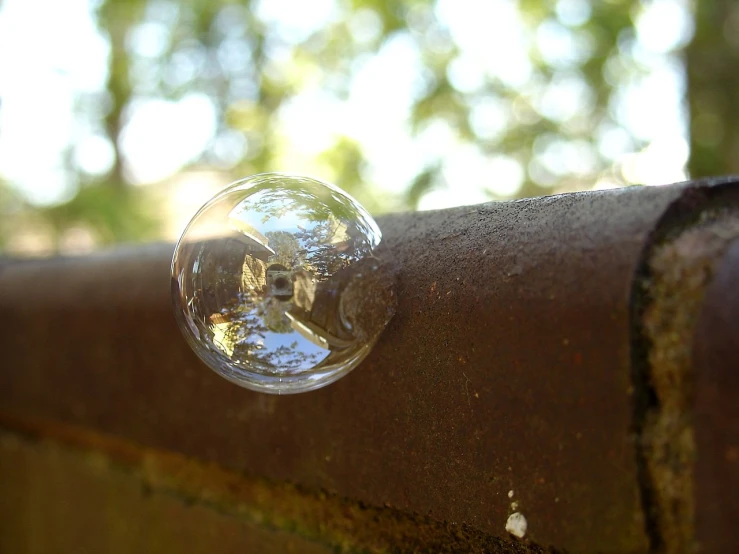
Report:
0,179,739,552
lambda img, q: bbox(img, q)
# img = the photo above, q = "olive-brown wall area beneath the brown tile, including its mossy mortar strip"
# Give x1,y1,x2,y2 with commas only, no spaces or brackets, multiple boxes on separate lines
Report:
0,420,557,554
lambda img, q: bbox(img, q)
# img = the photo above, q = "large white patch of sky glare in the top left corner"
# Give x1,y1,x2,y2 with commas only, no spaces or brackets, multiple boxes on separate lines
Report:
0,0,109,204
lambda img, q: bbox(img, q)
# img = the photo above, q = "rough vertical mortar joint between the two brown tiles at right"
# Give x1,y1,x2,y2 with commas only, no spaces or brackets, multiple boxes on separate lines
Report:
632,201,739,553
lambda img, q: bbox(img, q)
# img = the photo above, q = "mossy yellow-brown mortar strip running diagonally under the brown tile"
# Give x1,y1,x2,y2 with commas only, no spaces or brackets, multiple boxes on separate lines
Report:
0,413,558,554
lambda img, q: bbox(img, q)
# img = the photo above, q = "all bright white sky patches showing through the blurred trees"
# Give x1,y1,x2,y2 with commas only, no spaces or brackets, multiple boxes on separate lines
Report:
0,0,692,213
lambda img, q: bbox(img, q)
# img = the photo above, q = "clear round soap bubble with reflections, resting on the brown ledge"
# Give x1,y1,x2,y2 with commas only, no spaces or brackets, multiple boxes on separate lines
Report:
172,173,395,394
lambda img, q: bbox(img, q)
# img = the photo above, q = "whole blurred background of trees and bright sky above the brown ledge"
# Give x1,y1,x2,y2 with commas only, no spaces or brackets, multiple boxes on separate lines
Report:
0,0,739,255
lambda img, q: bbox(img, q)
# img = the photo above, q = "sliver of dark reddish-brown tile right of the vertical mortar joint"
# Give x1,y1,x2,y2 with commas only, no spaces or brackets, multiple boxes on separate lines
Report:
693,241,739,552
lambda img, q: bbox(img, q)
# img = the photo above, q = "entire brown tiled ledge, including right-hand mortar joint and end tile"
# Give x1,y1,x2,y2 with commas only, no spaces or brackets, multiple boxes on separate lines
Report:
0,178,739,552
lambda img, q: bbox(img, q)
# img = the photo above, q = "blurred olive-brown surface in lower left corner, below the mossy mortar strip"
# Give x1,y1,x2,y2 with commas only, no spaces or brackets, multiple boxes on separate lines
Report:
0,433,336,554
